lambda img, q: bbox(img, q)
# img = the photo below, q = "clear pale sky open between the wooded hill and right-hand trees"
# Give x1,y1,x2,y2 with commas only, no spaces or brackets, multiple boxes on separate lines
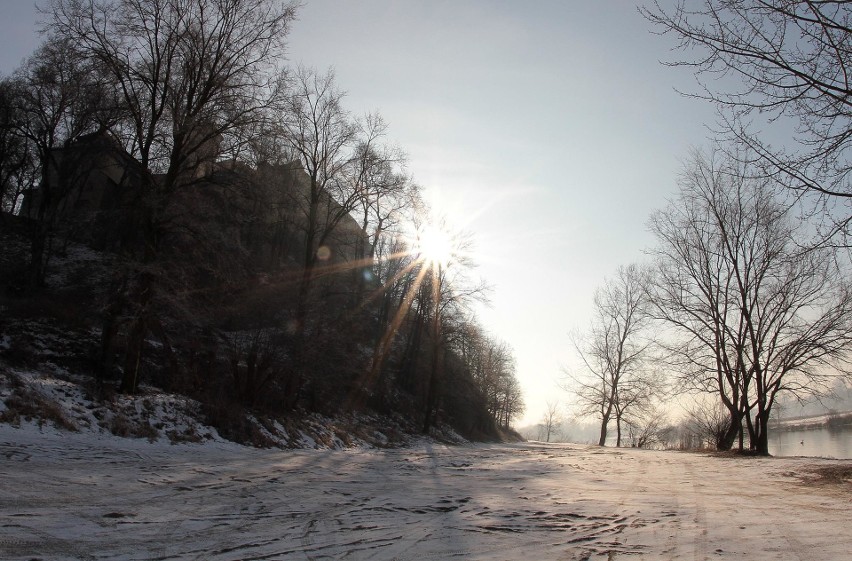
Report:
0,0,715,426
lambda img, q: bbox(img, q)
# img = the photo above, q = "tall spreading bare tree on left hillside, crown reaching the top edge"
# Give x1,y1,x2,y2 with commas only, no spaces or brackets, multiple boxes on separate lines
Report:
47,0,295,392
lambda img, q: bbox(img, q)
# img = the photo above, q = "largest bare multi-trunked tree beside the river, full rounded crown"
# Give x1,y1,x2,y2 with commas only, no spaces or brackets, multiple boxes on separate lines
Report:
651,149,852,454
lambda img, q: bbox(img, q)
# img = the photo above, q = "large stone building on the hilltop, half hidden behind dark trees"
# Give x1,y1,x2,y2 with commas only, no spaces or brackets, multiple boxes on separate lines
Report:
19,132,366,271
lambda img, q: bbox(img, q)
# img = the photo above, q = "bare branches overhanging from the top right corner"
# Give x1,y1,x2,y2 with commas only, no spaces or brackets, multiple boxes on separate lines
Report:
642,0,852,243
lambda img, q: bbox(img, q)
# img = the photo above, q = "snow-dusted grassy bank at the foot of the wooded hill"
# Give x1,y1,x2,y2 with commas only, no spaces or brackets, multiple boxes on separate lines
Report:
0,361,466,449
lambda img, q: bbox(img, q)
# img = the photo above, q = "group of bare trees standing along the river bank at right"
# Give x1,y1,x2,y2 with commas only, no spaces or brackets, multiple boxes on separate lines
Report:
573,152,852,454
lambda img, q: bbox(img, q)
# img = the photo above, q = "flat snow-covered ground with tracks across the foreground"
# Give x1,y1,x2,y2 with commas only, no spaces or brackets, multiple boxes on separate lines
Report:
0,425,852,560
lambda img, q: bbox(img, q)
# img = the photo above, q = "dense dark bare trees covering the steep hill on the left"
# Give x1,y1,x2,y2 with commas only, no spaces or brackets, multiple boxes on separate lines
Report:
0,0,522,434
